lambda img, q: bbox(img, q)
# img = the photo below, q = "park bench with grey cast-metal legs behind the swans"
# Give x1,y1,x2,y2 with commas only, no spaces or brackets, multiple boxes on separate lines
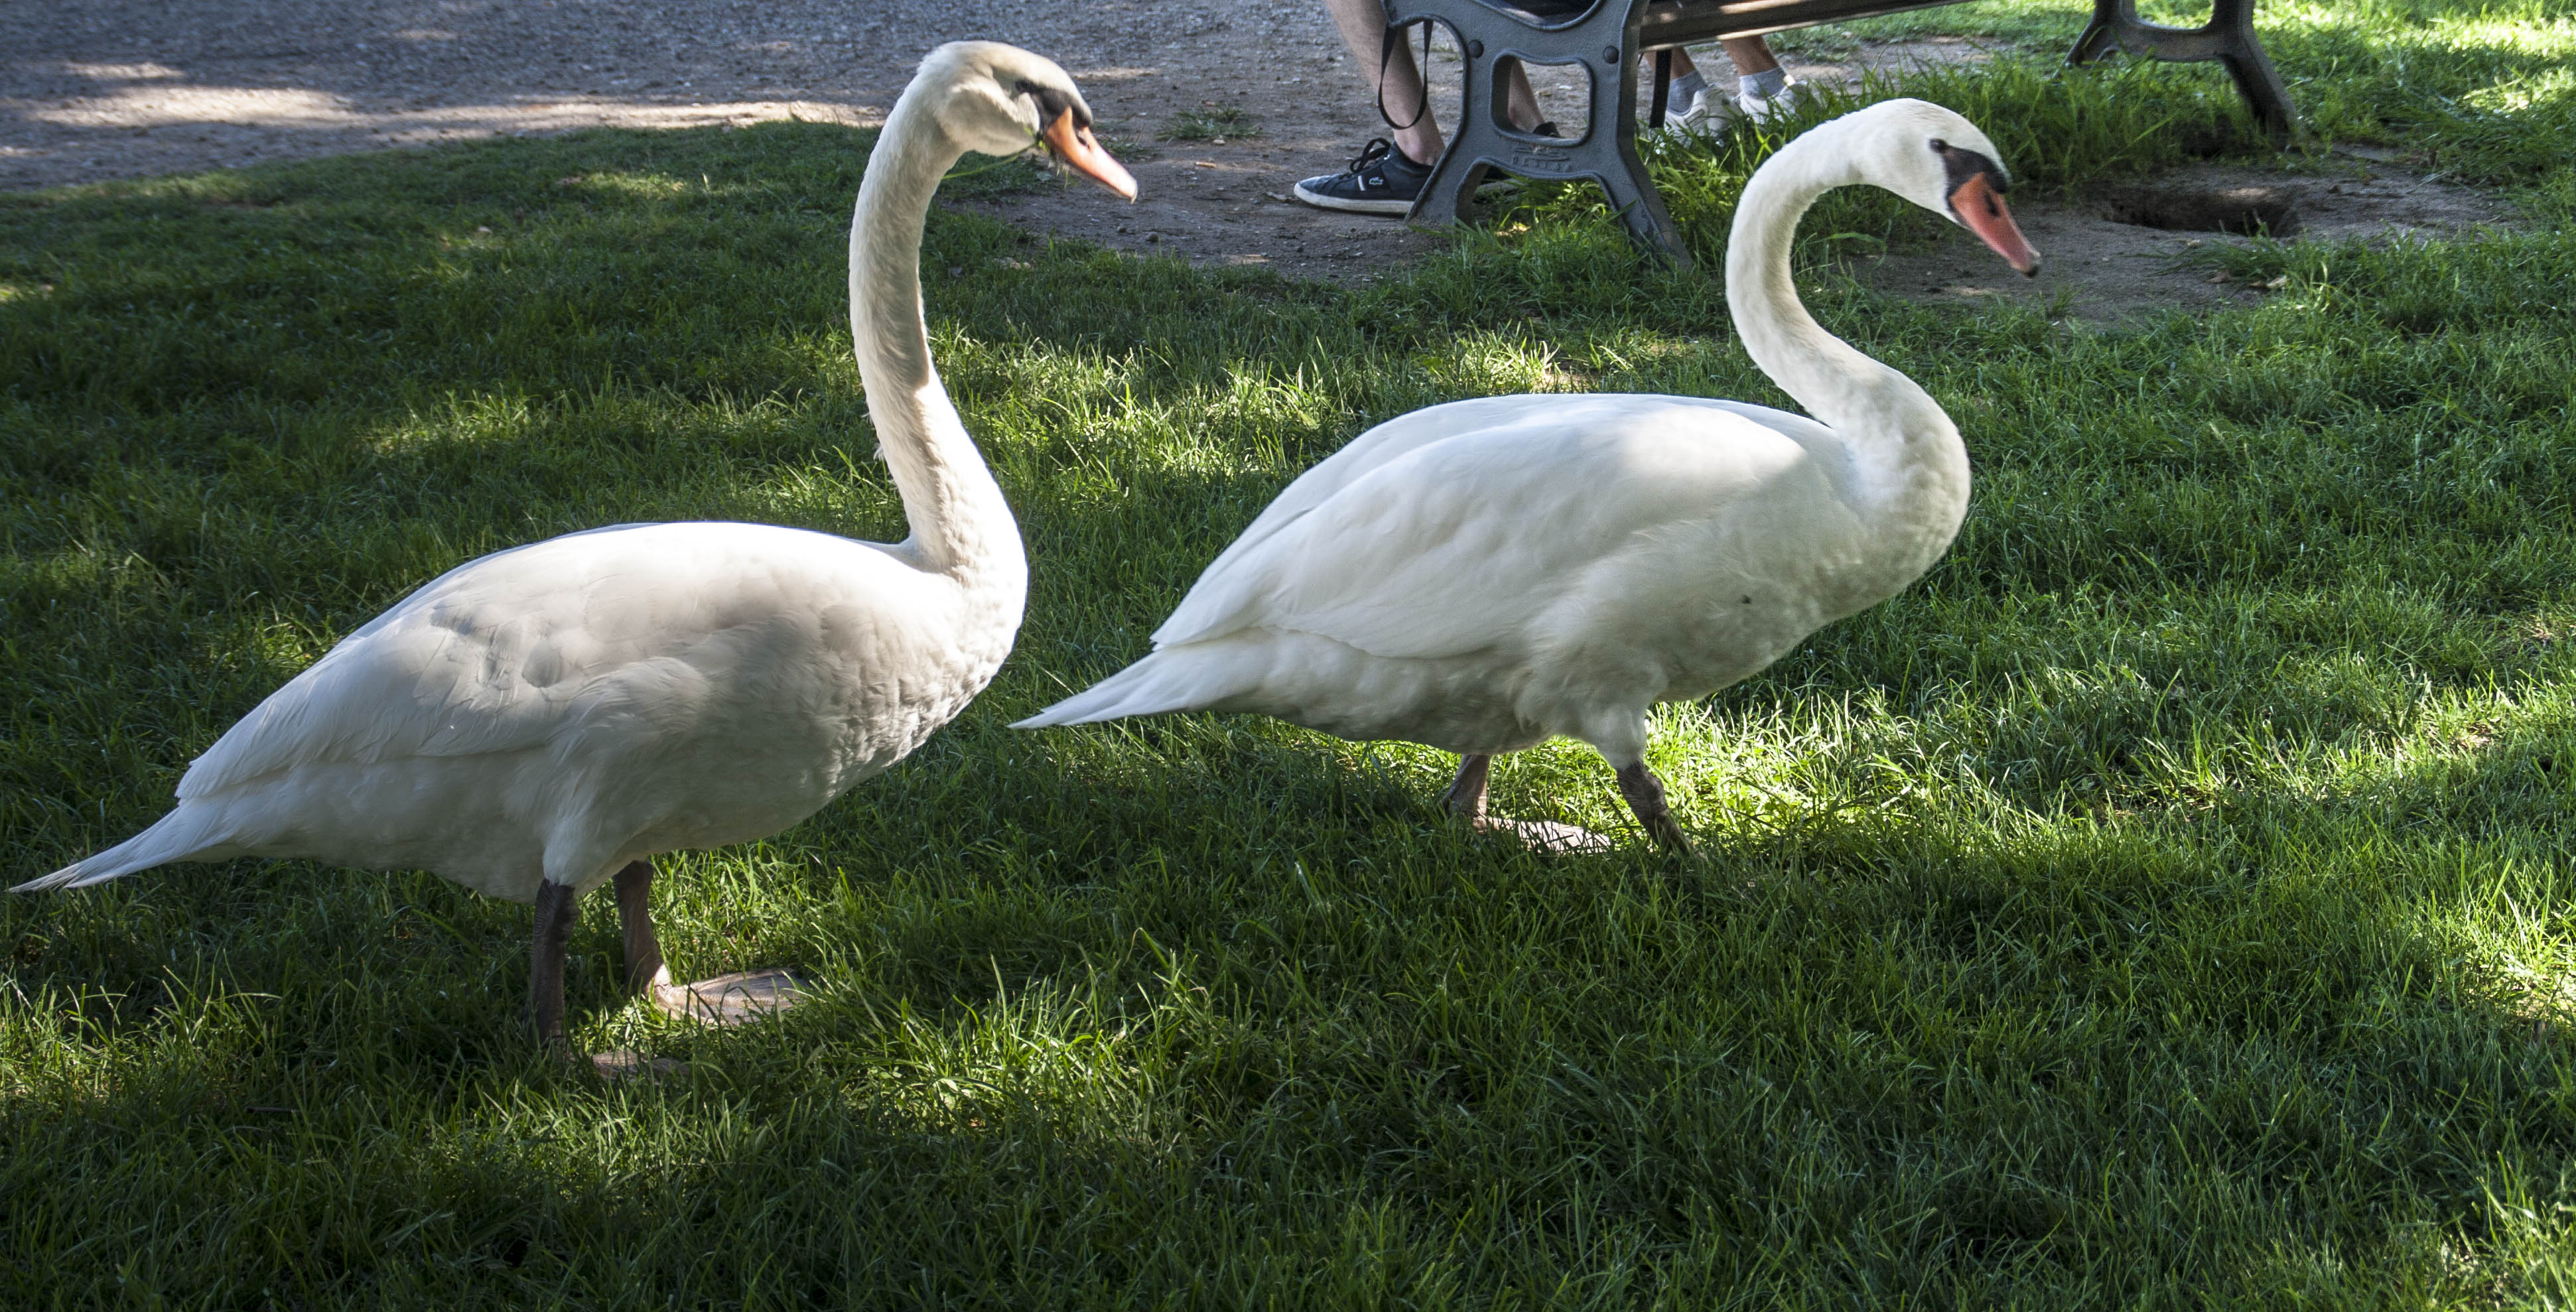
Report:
1386,0,2295,265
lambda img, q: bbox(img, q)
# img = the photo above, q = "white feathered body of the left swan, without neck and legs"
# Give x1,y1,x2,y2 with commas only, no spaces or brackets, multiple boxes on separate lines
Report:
47,523,1020,902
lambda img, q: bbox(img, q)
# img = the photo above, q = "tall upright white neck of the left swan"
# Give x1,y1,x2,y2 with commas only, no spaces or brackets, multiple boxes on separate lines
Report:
850,82,1028,574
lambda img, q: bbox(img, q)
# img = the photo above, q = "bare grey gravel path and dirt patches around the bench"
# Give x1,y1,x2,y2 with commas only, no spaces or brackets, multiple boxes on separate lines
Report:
0,0,2501,317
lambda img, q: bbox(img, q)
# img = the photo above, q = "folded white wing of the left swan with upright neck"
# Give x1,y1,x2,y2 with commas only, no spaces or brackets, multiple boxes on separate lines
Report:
178,523,902,797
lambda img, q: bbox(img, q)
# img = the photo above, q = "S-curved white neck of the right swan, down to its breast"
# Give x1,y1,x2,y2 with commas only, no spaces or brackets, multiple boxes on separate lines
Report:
1726,119,1968,551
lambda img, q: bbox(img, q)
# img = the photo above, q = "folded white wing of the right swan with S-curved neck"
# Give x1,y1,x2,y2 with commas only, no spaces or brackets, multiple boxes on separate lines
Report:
1154,397,1832,657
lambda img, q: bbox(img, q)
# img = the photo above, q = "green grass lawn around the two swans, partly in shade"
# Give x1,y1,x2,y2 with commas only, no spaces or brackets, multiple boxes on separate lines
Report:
15,0,2576,1309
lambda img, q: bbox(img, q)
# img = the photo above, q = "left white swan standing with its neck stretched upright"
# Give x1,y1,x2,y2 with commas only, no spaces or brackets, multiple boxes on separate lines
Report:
18,41,1136,1047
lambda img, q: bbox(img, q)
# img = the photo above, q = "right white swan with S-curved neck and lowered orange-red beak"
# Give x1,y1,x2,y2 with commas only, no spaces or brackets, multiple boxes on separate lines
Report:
1018,101,2037,850
